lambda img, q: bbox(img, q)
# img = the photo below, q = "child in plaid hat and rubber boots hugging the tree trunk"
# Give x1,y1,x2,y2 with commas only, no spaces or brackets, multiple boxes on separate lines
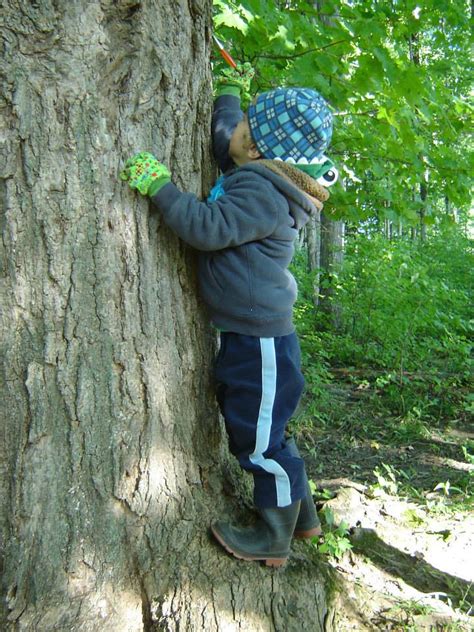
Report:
121,66,335,566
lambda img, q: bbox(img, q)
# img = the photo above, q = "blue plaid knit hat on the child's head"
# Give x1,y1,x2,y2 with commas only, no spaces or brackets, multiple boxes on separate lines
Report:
247,88,332,164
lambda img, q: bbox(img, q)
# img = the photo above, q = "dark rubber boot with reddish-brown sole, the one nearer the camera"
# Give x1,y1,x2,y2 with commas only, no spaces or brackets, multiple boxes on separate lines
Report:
211,500,300,566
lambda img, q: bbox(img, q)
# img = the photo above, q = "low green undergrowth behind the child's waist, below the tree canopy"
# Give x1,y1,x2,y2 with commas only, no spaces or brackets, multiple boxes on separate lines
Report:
294,226,474,420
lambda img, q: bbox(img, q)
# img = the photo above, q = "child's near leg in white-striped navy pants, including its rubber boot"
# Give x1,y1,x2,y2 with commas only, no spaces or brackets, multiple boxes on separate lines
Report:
212,333,307,566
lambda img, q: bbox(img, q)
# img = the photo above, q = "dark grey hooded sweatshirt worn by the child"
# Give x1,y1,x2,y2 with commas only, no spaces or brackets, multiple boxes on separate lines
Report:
152,92,324,338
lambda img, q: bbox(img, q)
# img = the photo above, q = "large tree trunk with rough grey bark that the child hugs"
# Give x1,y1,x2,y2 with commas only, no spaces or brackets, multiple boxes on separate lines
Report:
0,0,326,632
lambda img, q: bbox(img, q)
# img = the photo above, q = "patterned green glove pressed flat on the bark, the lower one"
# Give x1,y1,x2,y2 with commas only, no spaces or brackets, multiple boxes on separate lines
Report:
120,151,171,197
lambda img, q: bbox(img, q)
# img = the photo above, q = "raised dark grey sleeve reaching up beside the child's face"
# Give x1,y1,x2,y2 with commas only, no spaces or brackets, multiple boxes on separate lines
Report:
211,94,244,173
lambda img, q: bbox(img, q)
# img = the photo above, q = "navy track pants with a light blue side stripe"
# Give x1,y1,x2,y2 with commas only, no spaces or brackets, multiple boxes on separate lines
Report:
216,332,307,508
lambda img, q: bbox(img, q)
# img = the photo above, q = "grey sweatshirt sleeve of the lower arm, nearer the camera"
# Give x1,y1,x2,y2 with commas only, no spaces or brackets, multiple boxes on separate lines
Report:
151,178,278,251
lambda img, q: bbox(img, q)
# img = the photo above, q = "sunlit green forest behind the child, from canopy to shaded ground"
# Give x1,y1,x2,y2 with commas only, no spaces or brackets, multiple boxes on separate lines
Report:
214,0,474,596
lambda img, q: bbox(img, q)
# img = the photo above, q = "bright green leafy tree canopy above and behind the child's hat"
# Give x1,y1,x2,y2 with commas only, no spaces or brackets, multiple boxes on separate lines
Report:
214,0,473,224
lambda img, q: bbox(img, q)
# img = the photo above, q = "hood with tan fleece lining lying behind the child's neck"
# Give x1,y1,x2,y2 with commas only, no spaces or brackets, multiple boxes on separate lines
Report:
240,159,329,230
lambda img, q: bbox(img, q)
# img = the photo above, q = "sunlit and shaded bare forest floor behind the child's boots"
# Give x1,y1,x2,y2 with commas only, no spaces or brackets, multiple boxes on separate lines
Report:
296,375,474,632
